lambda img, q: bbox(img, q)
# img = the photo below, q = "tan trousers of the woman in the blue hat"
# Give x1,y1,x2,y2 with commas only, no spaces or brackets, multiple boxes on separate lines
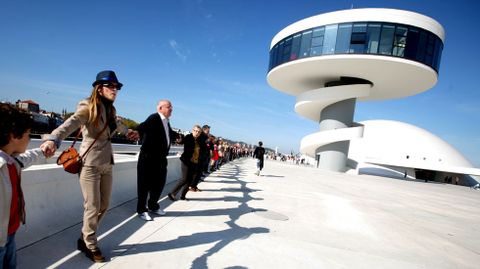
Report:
80,164,112,249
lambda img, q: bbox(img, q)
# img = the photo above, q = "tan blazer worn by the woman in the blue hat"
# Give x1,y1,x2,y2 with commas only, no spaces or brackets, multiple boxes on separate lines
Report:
52,99,118,166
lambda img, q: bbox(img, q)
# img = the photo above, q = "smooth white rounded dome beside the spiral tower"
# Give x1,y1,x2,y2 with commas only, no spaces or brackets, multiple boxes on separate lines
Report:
348,120,473,168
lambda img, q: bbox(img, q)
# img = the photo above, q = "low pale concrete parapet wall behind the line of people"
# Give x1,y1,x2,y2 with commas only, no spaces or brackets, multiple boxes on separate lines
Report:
16,155,181,248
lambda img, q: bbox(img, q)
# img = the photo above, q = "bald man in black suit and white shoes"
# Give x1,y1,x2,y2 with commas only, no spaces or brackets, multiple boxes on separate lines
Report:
137,100,178,221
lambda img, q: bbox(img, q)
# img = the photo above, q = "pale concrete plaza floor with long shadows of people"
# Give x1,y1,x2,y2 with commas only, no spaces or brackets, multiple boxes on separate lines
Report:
18,158,480,269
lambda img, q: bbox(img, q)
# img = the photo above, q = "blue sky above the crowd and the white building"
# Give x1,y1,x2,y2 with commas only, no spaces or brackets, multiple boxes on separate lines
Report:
0,0,480,167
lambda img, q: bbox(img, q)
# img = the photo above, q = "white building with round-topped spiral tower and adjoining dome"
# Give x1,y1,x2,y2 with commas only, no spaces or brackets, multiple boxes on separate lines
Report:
267,8,480,184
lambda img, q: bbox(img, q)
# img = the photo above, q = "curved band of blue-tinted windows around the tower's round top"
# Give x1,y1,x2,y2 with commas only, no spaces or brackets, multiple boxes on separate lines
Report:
268,22,443,73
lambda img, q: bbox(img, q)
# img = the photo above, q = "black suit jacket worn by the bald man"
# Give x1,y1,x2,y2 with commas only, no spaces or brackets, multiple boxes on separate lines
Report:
137,113,178,159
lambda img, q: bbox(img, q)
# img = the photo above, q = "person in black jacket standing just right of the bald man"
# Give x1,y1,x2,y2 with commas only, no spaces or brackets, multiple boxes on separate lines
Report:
168,125,205,201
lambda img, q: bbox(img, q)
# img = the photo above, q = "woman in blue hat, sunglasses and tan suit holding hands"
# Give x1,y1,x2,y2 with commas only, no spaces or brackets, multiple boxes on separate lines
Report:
43,70,135,262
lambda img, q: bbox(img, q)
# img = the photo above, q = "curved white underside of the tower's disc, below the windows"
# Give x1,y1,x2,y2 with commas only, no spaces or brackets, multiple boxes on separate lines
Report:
267,54,438,101
